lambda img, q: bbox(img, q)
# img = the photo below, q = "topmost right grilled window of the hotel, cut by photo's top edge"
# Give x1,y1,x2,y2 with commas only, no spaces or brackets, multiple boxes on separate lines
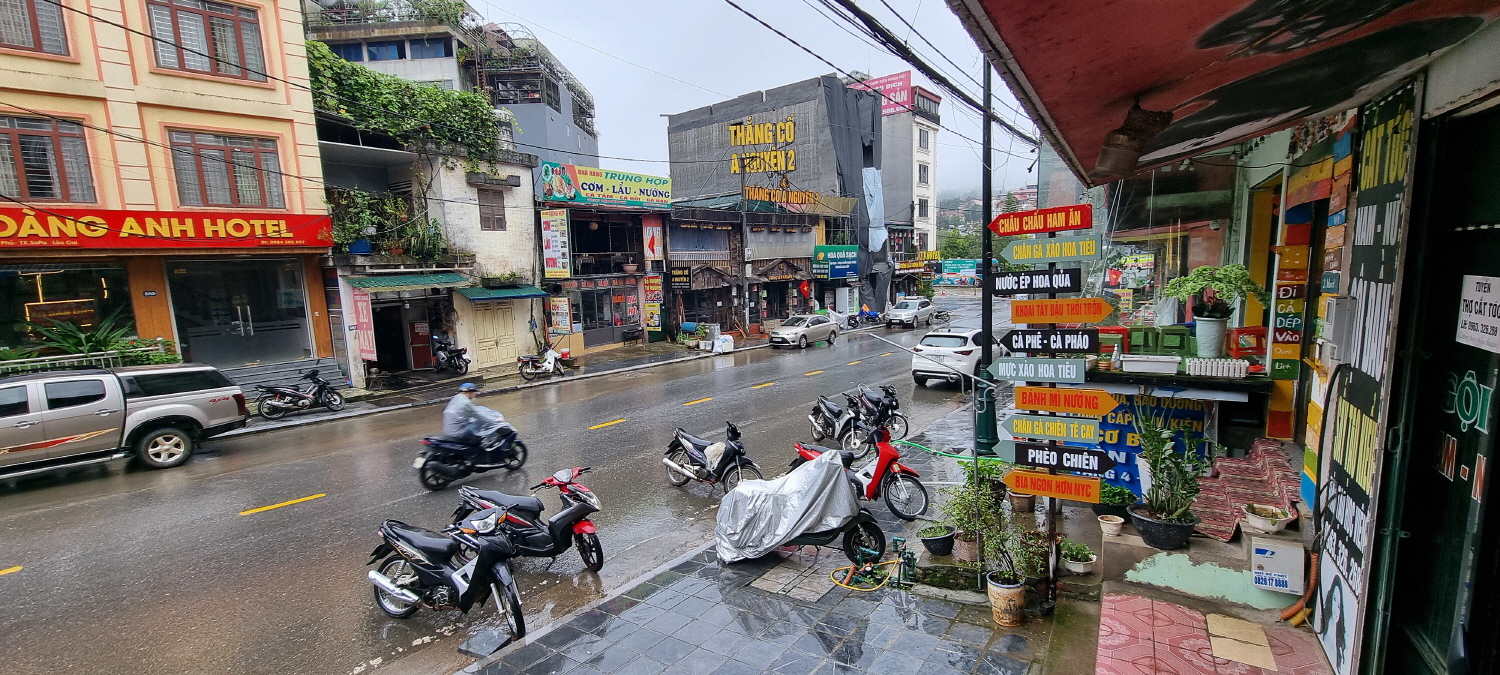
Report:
145,0,266,83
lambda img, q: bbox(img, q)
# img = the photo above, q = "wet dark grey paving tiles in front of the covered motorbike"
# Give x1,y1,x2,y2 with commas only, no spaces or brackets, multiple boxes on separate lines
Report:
480,551,1040,675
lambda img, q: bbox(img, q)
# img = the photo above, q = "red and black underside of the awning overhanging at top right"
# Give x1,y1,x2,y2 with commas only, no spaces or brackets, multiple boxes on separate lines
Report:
950,0,1500,185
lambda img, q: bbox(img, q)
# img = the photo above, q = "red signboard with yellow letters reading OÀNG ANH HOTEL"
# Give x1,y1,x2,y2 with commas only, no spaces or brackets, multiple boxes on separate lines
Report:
0,207,333,251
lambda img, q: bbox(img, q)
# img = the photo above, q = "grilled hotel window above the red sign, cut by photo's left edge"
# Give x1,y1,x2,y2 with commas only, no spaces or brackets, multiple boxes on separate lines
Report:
0,117,95,203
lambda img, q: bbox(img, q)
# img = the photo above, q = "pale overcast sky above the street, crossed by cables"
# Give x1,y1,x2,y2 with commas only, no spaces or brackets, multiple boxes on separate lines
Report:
470,0,1035,198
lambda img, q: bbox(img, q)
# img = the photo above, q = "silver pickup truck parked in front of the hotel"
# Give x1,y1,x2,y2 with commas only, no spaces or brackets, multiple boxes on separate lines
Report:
0,363,249,479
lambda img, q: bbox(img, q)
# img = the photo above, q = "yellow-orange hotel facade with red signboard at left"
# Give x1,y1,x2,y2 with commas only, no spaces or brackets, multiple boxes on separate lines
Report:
0,0,332,368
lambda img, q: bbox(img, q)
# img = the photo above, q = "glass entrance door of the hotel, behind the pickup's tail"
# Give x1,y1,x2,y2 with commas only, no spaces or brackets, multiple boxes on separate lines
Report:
167,258,312,368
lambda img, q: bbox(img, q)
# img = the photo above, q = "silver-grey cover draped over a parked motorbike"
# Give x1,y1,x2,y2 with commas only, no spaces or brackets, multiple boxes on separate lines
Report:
714,453,860,563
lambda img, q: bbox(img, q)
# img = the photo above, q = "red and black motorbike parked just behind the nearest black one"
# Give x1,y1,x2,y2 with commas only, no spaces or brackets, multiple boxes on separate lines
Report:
453,467,605,572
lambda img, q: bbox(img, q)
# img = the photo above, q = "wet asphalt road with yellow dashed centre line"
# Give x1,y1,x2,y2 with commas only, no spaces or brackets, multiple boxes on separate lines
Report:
0,292,978,675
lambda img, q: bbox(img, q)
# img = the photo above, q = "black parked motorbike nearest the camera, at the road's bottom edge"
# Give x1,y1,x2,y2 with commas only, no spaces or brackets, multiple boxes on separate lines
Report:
366,509,527,639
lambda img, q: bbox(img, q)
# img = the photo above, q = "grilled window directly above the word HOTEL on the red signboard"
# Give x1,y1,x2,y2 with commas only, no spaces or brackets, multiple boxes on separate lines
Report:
170,131,287,209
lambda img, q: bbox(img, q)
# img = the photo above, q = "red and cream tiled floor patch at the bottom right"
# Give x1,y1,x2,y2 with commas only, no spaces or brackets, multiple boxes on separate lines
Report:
1095,594,1332,675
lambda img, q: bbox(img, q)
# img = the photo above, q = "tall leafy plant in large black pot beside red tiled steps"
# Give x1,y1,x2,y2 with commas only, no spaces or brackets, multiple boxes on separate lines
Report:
1127,404,1218,551
